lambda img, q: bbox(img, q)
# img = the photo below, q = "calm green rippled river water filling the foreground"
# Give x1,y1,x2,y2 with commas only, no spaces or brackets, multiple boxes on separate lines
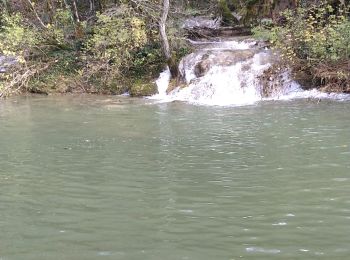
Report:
0,96,350,260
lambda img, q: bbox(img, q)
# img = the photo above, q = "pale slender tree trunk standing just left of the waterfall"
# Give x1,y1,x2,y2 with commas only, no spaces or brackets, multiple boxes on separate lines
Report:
159,0,179,78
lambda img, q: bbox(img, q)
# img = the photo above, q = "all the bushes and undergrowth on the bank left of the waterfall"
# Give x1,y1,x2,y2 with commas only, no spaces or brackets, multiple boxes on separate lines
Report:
0,0,194,96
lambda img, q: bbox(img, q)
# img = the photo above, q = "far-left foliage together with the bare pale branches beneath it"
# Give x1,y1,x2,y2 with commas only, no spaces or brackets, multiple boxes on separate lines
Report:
0,9,83,95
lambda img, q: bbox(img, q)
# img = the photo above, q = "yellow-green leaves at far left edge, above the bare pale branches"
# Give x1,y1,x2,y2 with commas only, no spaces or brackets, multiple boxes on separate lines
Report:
0,9,80,62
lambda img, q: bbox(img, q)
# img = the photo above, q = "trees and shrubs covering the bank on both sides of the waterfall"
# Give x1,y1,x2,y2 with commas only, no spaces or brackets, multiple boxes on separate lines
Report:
0,0,350,96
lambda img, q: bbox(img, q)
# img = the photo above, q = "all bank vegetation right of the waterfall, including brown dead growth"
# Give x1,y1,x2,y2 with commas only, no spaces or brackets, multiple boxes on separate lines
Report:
253,3,350,93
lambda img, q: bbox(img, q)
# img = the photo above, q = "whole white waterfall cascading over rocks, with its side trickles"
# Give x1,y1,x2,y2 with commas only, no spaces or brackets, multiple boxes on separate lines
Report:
152,37,349,106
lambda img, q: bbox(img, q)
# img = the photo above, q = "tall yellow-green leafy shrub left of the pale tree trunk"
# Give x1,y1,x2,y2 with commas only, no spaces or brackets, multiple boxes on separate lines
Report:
83,5,152,92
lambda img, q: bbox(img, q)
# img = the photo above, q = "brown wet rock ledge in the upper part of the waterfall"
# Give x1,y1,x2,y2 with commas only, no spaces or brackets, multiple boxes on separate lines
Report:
194,49,256,78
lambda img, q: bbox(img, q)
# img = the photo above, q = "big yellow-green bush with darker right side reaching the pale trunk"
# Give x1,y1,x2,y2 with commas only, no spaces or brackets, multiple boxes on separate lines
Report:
83,4,165,93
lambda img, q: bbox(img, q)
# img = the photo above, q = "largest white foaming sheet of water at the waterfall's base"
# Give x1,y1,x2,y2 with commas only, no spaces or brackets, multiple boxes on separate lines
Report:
169,54,269,106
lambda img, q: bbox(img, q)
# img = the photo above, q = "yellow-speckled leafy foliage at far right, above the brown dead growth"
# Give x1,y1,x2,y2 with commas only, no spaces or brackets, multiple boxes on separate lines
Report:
276,5,350,65
